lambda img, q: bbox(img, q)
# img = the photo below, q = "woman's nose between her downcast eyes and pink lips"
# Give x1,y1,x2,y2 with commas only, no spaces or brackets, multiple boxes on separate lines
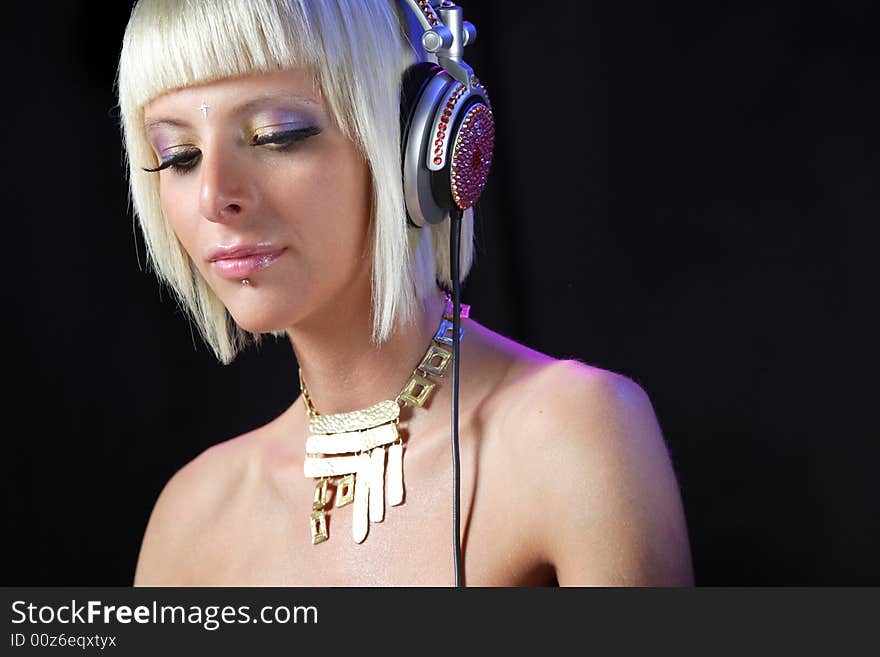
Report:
199,143,253,223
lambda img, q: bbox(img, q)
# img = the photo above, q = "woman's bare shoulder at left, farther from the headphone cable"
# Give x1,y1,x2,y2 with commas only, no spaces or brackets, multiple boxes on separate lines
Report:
134,428,265,586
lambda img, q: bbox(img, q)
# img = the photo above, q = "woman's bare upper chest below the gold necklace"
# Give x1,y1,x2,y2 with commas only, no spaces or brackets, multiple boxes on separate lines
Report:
180,430,552,586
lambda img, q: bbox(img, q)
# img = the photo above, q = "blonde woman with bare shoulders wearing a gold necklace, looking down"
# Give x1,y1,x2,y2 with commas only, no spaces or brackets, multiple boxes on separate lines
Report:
118,0,692,586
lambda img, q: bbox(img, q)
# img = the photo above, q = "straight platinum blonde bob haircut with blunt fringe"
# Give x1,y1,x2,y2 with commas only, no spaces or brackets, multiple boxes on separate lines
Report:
117,0,473,363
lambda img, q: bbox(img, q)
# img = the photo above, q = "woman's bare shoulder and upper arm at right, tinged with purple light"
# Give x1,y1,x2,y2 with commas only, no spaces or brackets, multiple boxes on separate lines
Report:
478,338,693,586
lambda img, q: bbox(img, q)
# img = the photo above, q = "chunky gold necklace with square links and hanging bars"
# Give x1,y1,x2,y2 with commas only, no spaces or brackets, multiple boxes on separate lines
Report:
299,294,470,545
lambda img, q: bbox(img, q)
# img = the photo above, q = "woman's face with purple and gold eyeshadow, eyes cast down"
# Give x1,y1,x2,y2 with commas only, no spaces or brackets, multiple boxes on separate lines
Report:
144,69,371,332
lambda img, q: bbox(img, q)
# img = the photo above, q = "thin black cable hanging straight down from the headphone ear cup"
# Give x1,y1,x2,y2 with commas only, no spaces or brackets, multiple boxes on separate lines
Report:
449,204,464,587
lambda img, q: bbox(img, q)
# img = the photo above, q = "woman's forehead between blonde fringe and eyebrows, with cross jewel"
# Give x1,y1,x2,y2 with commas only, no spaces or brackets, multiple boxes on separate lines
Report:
144,68,326,130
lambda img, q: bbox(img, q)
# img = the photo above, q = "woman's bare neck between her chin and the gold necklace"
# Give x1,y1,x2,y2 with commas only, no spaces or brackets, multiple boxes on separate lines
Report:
288,289,444,415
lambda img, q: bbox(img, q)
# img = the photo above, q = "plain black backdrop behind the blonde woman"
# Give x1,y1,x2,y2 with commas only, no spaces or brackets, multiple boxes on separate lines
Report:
0,1,880,585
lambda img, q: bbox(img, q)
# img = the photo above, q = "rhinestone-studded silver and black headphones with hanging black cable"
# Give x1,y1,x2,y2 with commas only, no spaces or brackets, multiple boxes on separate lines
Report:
400,0,495,587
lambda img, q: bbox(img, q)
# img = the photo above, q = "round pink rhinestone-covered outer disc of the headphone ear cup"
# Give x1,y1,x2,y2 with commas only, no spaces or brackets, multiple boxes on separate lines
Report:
450,103,495,210
